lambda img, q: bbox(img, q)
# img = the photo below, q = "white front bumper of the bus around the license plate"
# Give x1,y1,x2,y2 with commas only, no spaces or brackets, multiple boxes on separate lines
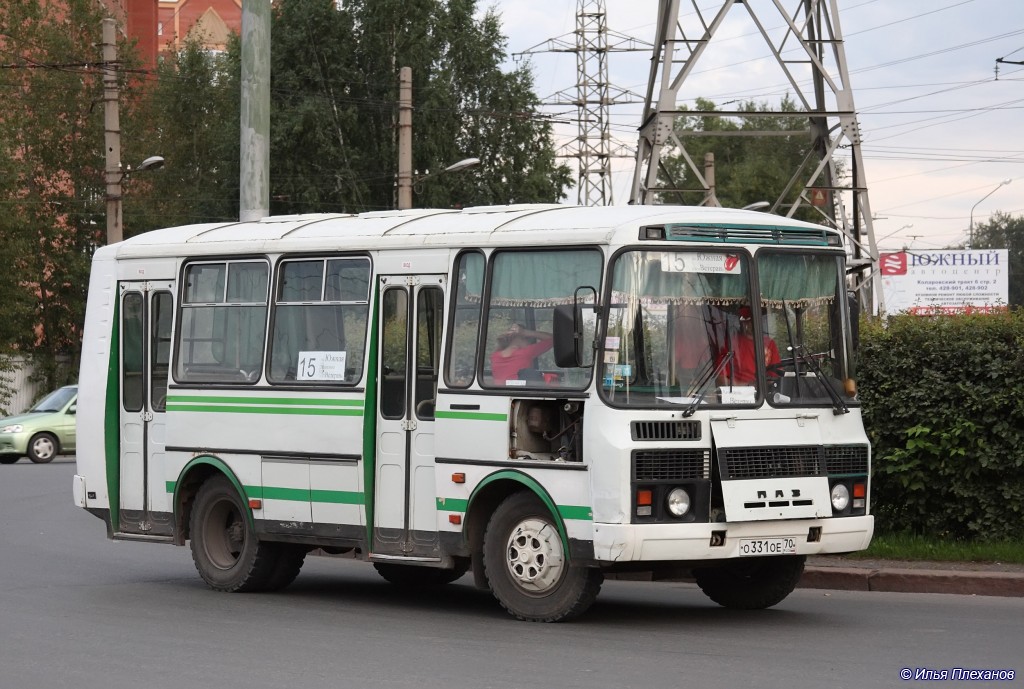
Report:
594,515,874,563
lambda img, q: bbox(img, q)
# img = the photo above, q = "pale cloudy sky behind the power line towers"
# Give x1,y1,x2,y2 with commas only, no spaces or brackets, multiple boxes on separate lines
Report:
479,0,1024,252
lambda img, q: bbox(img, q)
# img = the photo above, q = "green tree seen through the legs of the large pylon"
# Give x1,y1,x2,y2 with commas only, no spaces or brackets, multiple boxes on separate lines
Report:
659,96,819,220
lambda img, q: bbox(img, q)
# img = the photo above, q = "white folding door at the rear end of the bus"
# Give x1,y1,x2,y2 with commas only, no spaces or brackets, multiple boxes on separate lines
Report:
119,281,173,535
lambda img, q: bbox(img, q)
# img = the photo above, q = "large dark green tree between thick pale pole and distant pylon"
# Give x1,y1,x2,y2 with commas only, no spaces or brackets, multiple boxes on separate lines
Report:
270,0,571,213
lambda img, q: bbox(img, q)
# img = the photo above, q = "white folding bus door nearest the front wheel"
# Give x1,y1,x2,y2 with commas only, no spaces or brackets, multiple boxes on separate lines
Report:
371,275,445,560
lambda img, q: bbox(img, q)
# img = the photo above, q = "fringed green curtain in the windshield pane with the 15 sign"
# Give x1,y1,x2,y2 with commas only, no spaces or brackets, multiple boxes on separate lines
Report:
612,252,750,306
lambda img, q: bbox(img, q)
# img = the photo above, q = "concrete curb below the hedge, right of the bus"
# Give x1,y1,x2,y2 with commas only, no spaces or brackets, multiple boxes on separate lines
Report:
798,567,1024,598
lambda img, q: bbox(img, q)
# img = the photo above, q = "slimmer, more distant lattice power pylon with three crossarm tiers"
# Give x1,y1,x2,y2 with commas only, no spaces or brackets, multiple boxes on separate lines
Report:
515,0,651,206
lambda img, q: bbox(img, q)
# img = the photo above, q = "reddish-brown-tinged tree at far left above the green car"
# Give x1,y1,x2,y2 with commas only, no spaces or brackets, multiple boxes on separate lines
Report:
0,0,112,387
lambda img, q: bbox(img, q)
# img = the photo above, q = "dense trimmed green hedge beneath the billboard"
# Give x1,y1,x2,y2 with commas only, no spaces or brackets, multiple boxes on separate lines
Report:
858,309,1024,541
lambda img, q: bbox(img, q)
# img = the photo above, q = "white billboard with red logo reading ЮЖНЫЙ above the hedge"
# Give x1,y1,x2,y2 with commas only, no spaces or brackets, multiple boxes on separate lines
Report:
879,249,1010,315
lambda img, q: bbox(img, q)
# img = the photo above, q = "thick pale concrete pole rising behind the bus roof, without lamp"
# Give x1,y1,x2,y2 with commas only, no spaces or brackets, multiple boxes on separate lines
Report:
239,0,270,221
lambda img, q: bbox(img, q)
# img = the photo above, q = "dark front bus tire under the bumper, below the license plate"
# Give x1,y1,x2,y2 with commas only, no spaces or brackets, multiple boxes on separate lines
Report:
693,555,807,610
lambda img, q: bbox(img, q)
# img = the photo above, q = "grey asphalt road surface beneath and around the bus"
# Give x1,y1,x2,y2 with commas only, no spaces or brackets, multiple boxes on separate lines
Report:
0,459,1024,689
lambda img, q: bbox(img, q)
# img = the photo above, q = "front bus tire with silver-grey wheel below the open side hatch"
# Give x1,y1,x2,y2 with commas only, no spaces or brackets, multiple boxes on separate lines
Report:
483,492,604,622
